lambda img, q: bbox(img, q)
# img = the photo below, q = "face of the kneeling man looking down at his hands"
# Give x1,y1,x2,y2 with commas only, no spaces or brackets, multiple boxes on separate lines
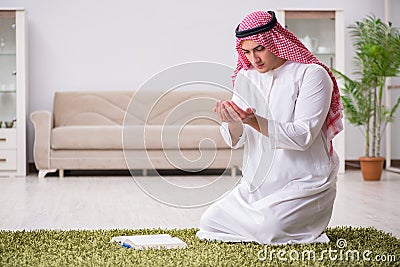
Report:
241,40,281,73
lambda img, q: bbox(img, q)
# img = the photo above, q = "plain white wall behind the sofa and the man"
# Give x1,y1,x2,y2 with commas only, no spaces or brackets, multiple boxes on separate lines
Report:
0,0,400,162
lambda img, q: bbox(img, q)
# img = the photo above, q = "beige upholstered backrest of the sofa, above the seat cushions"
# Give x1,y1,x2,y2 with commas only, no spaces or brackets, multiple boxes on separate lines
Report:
53,89,232,127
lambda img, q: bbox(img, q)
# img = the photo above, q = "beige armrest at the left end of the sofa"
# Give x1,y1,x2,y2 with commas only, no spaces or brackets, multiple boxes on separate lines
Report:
30,110,53,170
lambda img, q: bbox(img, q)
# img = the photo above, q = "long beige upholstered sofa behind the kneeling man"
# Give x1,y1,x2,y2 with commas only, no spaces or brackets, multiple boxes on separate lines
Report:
31,90,243,177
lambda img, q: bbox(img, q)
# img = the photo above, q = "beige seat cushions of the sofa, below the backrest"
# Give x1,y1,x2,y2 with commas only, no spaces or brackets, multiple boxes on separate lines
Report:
51,125,228,150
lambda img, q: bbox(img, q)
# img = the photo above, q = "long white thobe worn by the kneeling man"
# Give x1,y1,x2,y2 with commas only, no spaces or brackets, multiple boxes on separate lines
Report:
197,61,338,244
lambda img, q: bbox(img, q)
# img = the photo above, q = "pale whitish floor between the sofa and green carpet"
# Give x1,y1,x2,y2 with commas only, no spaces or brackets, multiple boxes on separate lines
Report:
0,171,400,237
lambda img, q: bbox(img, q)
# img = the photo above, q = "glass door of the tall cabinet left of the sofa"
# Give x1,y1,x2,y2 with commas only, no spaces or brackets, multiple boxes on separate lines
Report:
0,11,16,128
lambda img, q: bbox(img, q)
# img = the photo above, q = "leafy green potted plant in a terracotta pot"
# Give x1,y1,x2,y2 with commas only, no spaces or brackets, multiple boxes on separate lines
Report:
334,15,400,180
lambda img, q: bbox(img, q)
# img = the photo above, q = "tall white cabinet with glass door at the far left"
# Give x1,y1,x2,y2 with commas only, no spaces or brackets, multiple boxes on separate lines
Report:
0,9,27,176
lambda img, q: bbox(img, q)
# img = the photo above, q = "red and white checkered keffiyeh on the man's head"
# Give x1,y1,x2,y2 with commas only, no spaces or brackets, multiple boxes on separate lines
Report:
232,11,343,155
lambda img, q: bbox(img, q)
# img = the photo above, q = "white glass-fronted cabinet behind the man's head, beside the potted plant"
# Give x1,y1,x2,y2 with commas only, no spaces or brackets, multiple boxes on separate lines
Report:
276,9,346,173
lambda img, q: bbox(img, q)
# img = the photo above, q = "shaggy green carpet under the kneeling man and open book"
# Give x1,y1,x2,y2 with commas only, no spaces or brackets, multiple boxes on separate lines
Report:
0,227,400,266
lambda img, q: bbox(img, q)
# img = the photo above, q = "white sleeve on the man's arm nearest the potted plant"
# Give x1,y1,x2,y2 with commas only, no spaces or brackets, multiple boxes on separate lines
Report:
268,67,333,151
